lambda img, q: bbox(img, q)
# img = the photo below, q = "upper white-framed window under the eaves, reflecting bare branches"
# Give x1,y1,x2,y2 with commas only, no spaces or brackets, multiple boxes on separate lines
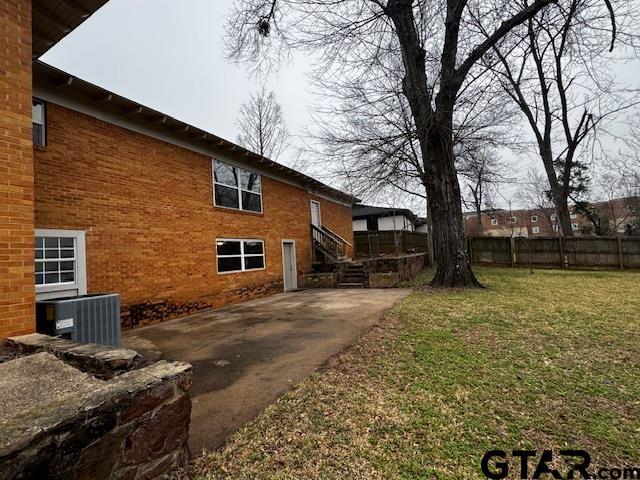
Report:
211,159,262,213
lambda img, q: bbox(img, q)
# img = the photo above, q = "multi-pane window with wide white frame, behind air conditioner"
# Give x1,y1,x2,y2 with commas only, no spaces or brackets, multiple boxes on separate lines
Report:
35,229,87,298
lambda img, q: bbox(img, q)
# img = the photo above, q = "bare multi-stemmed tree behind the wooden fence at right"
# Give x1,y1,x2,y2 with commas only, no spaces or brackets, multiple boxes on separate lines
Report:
485,0,638,236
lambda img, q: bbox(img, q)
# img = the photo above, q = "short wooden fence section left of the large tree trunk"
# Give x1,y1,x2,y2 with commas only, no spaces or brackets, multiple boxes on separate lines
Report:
353,230,429,257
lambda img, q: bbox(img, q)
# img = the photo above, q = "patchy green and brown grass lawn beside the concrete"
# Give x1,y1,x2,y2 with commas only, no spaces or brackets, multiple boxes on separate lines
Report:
181,269,640,479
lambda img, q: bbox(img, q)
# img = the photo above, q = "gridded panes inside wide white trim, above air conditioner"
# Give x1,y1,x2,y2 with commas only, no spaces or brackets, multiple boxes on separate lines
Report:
36,237,77,285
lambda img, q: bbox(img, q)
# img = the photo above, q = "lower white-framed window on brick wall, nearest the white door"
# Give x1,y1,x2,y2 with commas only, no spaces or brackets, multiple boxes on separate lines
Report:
216,238,265,273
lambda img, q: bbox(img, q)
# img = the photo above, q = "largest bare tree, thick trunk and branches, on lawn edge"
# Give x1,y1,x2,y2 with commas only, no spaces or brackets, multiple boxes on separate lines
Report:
227,0,556,287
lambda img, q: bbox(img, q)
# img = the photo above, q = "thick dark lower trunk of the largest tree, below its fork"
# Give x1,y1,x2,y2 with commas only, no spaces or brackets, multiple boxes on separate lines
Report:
423,126,482,288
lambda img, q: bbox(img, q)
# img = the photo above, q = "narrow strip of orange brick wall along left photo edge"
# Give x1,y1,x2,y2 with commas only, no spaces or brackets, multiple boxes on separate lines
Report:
0,0,35,338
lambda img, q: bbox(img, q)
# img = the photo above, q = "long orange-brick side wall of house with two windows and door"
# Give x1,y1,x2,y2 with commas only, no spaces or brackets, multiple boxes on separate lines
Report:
35,104,353,325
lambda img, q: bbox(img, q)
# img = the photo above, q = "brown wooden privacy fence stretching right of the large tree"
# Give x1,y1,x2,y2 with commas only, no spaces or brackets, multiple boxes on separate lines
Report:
467,237,640,269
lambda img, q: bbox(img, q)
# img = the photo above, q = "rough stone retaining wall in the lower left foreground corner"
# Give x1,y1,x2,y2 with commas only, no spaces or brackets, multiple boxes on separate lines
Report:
0,342,192,480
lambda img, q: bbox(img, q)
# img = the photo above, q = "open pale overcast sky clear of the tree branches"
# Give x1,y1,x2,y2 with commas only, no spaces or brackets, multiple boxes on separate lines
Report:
42,0,639,212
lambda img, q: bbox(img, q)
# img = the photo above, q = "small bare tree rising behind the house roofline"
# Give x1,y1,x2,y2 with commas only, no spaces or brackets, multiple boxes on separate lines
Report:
237,87,289,160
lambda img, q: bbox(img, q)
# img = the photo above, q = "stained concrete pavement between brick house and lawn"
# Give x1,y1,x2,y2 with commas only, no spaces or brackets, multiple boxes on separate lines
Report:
123,289,410,454
